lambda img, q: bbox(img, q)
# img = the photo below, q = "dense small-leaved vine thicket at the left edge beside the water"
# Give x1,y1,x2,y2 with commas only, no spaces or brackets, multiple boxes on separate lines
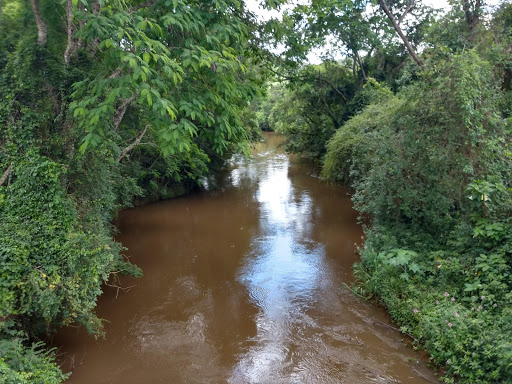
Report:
0,154,138,333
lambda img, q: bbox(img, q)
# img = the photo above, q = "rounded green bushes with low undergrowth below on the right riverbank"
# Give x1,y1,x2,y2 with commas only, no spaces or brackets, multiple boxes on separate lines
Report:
323,51,512,383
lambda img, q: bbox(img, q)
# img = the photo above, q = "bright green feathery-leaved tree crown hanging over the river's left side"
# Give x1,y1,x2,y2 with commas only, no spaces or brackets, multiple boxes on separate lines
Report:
70,1,256,156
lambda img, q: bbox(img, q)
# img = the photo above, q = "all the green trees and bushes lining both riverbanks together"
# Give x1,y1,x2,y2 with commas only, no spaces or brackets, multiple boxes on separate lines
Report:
0,0,512,383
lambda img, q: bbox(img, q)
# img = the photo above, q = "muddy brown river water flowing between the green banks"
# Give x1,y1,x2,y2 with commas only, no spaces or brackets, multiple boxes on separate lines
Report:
54,135,438,384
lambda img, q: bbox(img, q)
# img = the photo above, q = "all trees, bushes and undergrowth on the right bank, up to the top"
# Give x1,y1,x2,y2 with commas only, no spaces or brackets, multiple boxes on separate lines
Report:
262,0,512,383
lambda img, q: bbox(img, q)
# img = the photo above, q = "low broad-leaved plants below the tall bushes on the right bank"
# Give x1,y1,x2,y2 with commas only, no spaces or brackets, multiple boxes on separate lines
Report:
354,228,512,383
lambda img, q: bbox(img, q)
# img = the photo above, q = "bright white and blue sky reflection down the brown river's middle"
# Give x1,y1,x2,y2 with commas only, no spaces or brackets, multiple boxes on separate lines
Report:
230,155,324,382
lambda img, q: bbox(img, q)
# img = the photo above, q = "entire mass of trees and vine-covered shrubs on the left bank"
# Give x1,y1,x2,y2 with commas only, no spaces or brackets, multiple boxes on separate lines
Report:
0,0,261,383
